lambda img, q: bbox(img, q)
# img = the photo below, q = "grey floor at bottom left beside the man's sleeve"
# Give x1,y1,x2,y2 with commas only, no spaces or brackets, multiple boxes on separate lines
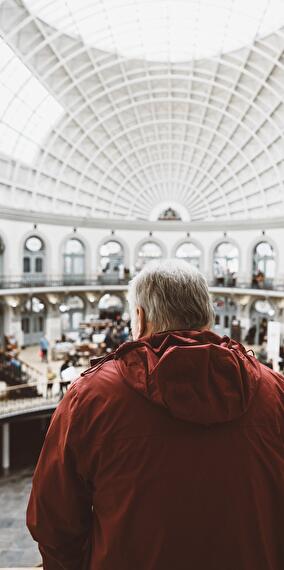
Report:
0,470,41,568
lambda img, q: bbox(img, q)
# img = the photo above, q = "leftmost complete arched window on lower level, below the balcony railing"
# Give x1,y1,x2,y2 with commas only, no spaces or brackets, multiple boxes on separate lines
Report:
21,297,46,346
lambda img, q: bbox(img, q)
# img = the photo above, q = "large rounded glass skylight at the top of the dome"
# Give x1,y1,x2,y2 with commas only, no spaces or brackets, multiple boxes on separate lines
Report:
25,0,284,61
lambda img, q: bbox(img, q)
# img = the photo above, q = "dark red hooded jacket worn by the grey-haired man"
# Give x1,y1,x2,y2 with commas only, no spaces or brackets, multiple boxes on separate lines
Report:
27,331,284,570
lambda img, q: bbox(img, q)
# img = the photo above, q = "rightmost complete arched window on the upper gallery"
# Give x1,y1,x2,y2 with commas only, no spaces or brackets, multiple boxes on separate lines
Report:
252,241,276,289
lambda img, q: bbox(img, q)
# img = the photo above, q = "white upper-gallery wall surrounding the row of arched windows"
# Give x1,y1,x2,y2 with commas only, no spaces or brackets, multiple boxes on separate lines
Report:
0,220,284,281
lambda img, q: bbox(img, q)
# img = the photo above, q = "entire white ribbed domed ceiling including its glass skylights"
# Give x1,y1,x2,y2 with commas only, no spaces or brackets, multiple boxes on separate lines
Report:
0,0,284,224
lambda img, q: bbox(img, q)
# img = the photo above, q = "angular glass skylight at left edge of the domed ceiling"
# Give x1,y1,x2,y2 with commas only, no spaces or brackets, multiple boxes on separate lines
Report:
0,39,63,164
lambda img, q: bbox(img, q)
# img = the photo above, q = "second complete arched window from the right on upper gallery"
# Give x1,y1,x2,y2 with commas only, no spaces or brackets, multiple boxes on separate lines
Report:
213,242,239,287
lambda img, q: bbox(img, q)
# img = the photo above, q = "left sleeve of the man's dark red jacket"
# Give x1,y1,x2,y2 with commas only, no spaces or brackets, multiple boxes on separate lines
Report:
27,383,92,570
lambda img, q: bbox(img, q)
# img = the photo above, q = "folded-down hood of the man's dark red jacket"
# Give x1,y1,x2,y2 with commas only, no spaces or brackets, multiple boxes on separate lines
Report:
115,331,261,426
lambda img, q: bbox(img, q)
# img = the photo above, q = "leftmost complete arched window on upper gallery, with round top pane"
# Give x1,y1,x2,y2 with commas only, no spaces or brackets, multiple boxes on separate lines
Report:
23,236,45,279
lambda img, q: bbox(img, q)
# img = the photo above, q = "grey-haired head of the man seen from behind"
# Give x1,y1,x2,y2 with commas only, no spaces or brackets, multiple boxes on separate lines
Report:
128,259,214,339
